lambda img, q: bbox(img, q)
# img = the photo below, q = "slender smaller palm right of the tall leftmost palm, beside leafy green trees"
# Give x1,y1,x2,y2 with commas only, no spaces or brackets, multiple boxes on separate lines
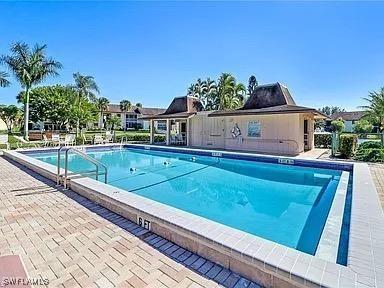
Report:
72,72,99,136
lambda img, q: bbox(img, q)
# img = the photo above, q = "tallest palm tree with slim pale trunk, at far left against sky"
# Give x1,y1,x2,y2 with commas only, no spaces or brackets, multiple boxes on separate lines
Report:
0,42,62,140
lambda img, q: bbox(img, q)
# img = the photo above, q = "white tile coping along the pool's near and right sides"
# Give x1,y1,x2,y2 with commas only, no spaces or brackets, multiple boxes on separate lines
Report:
4,145,384,287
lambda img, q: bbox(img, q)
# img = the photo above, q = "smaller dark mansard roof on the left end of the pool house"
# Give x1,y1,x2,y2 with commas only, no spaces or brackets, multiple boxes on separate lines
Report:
145,96,203,119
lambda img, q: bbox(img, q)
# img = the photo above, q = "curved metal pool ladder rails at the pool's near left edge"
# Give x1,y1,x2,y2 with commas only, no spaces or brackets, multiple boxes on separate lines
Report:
56,146,108,189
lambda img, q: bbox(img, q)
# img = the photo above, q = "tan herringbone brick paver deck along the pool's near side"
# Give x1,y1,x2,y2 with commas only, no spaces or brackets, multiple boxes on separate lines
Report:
0,157,259,288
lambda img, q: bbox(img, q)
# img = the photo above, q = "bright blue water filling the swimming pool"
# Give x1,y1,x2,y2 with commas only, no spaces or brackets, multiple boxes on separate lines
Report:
30,149,342,254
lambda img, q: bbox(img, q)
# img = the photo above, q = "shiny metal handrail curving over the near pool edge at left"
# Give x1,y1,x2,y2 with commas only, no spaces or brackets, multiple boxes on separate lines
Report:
56,146,108,188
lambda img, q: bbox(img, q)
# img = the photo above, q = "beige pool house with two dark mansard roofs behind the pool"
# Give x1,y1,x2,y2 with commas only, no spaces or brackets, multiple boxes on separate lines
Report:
144,83,327,155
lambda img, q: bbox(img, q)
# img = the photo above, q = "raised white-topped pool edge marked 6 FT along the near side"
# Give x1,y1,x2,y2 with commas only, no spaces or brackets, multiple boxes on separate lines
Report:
4,147,374,287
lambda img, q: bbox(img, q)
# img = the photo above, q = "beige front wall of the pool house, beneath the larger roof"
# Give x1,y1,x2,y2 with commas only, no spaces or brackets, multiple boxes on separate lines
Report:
190,112,314,154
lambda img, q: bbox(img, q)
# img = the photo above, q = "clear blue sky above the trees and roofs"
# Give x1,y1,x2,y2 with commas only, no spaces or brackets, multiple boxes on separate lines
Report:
0,1,384,110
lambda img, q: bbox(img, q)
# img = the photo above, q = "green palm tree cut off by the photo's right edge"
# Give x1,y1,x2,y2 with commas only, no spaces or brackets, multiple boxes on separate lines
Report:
361,87,384,132
